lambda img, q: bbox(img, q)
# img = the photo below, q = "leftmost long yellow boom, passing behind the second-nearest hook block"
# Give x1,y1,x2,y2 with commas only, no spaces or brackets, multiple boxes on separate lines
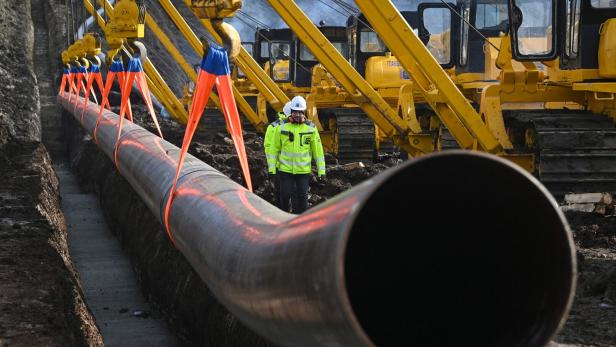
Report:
83,0,188,124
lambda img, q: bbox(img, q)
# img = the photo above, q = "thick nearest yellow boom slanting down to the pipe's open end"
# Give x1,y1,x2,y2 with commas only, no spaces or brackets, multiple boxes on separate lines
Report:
354,0,502,153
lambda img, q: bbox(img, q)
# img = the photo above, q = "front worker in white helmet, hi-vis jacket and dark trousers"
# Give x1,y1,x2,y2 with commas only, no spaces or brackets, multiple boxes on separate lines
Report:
267,96,325,214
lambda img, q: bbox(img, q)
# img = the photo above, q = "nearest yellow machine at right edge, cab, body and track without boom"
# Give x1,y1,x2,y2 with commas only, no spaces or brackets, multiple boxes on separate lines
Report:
494,0,616,192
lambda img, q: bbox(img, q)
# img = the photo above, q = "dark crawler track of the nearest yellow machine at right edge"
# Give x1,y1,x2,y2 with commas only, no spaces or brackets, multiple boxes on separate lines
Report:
506,110,616,196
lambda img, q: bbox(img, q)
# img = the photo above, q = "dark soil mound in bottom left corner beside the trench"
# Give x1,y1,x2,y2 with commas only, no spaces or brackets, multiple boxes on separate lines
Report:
0,143,103,346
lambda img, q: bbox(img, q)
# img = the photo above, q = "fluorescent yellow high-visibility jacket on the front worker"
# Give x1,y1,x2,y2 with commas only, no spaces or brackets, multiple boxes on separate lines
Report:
266,119,325,176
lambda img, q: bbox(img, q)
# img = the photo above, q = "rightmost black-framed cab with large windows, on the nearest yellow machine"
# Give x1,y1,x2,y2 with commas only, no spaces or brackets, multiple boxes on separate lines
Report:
509,0,616,76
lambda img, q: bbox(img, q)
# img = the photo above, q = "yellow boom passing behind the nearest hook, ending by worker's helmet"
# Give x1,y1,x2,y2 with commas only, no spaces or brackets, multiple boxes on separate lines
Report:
159,0,268,132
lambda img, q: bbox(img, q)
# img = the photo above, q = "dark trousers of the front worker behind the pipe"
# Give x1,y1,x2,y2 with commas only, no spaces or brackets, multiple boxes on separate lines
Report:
276,171,310,214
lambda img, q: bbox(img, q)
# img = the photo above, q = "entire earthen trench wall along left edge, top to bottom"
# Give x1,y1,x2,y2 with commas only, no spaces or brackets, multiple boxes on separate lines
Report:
0,1,102,346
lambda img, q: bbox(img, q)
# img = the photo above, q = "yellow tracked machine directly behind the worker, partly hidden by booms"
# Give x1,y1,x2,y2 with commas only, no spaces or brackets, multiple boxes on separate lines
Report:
250,25,375,162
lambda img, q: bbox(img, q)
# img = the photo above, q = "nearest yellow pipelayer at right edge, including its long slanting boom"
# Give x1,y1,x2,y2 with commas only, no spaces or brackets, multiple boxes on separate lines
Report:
356,0,616,195
